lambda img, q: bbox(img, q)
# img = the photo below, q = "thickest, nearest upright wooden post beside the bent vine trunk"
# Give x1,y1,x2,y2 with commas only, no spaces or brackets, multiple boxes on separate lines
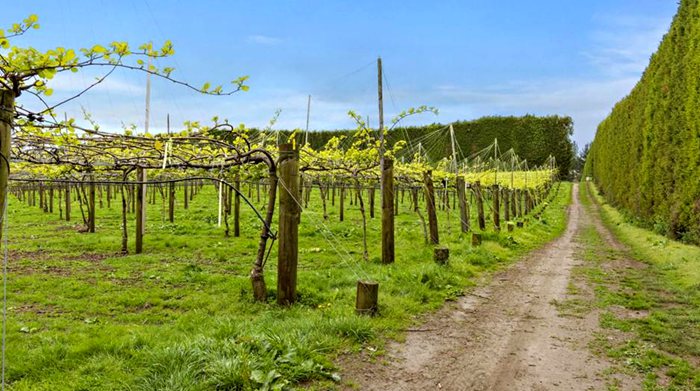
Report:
277,144,301,305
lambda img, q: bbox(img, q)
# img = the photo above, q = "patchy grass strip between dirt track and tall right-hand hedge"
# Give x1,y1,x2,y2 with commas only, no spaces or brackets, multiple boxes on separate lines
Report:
581,184,700,390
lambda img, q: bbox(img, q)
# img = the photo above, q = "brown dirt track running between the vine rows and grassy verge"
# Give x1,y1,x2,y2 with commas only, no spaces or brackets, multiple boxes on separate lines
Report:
347,185,620,390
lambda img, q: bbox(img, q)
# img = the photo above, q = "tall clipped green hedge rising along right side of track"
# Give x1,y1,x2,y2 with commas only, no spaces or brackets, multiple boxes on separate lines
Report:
584,0,700,244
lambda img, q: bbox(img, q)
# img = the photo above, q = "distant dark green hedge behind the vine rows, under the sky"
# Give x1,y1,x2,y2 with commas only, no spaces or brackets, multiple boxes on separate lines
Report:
284,115,575,177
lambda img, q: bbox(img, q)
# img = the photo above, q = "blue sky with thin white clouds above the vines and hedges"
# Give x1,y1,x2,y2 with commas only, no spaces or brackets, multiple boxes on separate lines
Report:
0,0,677,149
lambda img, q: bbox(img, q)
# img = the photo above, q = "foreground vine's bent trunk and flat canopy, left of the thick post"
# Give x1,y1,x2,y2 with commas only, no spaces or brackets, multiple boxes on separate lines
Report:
3,123,278,300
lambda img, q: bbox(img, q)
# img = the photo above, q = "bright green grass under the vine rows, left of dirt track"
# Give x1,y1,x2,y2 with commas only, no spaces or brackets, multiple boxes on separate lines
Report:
7,183,571,390
